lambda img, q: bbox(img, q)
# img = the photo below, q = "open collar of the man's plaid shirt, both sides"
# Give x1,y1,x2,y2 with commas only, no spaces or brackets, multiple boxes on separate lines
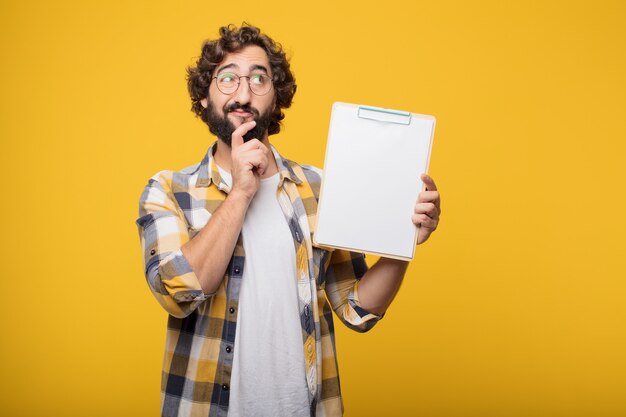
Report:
196,141,306,192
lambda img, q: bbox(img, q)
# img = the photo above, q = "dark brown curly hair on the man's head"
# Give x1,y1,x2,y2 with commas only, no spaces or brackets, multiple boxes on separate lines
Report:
187,23,296,135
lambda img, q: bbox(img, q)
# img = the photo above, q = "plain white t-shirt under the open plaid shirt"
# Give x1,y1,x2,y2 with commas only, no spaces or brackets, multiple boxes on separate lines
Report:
220,169,310,417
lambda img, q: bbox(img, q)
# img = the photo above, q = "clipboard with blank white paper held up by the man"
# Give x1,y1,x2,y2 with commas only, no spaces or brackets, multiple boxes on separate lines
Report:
313,102,435,260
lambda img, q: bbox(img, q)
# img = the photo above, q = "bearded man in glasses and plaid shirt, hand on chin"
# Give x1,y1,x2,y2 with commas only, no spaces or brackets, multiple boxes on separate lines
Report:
137,25,440,417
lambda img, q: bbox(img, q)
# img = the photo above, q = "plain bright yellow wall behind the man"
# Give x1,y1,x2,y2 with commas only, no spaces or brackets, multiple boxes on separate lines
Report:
0,0,626,417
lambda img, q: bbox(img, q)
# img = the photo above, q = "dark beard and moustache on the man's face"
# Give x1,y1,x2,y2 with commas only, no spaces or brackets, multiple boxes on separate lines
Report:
206,100,271,147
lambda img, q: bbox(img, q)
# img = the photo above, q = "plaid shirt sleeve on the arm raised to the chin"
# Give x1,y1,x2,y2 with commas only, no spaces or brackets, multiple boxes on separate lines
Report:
137,171,212,318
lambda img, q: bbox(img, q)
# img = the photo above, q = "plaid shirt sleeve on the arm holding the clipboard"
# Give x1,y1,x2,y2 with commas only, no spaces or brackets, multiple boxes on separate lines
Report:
323,249,382,332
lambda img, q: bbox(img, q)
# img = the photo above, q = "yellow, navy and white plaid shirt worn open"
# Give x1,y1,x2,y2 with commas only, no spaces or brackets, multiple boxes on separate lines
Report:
137,144,380,416
